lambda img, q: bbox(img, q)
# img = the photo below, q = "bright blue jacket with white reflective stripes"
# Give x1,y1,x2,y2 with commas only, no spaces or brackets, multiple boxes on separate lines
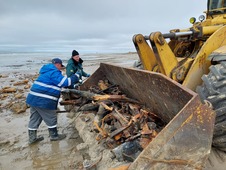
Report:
26,64,78,110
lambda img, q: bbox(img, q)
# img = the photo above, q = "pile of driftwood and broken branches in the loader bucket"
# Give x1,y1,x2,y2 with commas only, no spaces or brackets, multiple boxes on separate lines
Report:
60,80,165,162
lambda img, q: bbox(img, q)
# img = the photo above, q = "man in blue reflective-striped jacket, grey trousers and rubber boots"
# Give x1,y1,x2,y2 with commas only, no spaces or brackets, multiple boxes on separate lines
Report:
26,58,80,144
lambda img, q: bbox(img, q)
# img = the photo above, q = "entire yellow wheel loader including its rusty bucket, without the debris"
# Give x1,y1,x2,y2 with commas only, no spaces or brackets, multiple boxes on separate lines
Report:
62,0,226,170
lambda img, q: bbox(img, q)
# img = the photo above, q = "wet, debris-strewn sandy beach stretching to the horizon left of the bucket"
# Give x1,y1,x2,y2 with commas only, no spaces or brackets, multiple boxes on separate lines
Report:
0,53,138,170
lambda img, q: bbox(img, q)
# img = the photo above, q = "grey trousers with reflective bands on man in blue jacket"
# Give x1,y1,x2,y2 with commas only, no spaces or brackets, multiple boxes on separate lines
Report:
28,106,57,130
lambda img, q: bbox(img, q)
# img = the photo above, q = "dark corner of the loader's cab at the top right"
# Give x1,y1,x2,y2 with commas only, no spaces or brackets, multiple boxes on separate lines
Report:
207,0,226,16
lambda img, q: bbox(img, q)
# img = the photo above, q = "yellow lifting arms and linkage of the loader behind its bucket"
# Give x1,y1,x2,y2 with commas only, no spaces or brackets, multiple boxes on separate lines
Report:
133,25,226,91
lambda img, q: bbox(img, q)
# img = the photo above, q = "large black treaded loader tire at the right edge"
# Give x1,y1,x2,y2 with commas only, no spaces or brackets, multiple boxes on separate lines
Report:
196,62,226,151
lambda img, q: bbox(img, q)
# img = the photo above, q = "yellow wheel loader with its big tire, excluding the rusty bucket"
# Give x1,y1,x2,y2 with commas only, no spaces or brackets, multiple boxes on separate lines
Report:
130,0,226,169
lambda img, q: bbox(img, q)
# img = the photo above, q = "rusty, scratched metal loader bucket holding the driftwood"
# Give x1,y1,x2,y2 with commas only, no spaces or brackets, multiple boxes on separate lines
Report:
81,63,215,170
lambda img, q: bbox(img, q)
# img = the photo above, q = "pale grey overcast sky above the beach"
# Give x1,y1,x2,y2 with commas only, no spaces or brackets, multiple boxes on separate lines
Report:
0,0,207,53
